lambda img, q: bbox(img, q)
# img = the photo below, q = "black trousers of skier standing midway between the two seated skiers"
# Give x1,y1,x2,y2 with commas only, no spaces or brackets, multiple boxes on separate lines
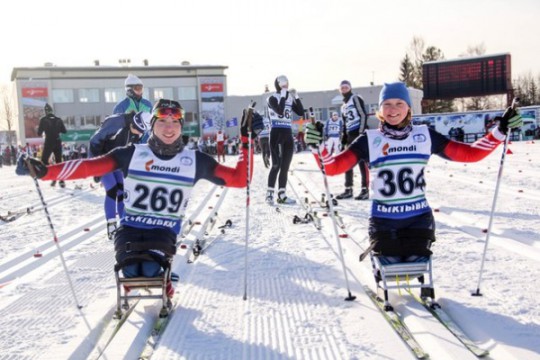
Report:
268,128,294,189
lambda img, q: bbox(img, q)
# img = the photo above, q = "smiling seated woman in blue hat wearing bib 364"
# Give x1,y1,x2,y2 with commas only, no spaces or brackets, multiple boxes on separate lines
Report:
306,82,523,262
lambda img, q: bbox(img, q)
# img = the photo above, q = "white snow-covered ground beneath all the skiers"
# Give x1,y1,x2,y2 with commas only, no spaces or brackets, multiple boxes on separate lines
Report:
0,142,540,360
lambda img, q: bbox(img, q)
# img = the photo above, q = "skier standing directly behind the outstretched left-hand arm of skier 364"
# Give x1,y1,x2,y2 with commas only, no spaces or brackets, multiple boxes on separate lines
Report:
336,80,369,200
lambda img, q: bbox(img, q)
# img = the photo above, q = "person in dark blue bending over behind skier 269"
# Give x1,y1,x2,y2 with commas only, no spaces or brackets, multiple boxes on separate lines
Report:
90,112,151,240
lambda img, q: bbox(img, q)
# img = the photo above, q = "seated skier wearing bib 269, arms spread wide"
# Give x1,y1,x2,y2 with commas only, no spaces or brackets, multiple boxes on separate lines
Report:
17,99,262,296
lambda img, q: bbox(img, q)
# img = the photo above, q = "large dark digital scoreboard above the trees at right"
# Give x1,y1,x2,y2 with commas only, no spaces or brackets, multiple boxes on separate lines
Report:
422,54,512,100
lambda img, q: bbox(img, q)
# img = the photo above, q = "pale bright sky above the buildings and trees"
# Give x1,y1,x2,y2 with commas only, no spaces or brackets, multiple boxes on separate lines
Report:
0,0,540,95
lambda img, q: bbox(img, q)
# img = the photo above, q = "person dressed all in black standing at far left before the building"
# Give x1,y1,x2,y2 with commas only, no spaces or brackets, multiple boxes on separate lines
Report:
38,104,67,187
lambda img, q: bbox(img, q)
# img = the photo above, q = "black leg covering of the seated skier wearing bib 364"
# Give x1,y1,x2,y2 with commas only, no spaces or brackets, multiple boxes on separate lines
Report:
360,229,435,261
